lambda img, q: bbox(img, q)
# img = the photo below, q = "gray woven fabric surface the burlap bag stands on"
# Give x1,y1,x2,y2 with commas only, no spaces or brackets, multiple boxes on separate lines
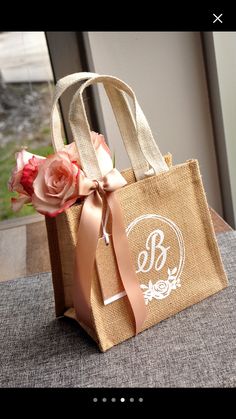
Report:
0,231,236,387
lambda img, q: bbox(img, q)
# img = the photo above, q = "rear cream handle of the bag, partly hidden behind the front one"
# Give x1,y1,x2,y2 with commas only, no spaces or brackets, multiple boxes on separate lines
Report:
51,72,149,180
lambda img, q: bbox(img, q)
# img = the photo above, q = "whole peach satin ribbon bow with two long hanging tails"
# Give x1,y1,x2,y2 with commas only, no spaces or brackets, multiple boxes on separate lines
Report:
73,169,146,334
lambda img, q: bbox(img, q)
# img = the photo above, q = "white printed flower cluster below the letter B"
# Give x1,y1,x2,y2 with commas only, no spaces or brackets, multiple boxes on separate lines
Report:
140,267,181,305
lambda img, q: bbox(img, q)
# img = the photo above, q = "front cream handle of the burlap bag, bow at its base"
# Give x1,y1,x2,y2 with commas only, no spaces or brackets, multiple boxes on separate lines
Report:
69,75,169,179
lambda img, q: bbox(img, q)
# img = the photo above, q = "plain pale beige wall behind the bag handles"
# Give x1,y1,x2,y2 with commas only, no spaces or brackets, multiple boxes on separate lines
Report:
88,32,222,214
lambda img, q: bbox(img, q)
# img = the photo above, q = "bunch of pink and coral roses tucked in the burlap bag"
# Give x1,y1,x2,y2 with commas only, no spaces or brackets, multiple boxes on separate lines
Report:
8,131,113,217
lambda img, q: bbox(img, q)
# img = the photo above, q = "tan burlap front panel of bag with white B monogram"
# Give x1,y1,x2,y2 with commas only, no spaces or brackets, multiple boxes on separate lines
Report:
92,161,227,350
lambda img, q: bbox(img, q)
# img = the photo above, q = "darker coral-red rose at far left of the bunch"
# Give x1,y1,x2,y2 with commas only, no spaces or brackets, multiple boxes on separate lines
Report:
8,149,45,211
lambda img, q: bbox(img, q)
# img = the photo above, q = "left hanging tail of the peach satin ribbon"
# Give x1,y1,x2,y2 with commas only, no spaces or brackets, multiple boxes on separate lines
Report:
73,191,102,329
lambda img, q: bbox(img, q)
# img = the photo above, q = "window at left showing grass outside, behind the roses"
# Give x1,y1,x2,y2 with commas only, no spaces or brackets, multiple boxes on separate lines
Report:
0,32,53,220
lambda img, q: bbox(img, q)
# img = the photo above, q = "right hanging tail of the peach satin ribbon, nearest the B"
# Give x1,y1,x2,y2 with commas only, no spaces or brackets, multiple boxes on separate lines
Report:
106,192,147,335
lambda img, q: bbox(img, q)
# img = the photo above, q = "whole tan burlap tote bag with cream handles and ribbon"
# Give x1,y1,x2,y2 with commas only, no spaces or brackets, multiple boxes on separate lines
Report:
47,73,227,351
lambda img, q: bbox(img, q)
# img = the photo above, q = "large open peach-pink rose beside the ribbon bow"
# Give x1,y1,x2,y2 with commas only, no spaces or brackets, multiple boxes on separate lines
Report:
32,151,80,217
